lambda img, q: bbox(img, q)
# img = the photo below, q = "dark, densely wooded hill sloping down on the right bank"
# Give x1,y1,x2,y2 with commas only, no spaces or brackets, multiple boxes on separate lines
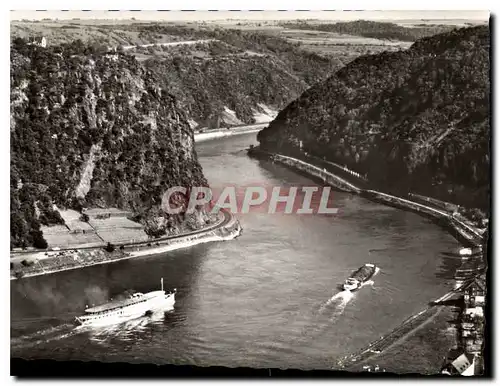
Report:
258,26,490,209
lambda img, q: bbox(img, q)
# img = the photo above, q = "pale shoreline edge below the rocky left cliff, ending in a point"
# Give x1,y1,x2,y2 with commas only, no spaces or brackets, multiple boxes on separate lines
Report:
10,211,242,281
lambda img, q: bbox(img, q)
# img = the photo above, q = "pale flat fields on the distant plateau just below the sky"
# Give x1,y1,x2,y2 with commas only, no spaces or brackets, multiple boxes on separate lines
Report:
11,20,458,63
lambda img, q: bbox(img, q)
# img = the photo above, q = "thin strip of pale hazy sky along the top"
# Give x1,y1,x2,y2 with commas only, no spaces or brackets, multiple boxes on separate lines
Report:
10,10,489,21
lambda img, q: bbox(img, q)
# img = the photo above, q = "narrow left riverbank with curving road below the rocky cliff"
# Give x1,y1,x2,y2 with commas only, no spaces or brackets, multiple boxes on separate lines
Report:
11,211,242,280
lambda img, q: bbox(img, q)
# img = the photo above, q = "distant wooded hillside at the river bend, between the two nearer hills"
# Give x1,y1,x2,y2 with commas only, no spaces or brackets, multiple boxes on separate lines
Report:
131,25,344,128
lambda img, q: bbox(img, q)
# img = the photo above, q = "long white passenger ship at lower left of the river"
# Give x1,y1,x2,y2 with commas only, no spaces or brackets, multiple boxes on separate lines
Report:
75,278,177,326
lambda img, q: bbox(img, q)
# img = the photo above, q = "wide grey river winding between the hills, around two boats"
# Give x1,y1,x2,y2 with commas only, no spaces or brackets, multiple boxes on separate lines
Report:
11,133,459,371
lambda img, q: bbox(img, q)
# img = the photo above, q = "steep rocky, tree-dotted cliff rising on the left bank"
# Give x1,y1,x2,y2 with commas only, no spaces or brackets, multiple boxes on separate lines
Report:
10,40,206,246
